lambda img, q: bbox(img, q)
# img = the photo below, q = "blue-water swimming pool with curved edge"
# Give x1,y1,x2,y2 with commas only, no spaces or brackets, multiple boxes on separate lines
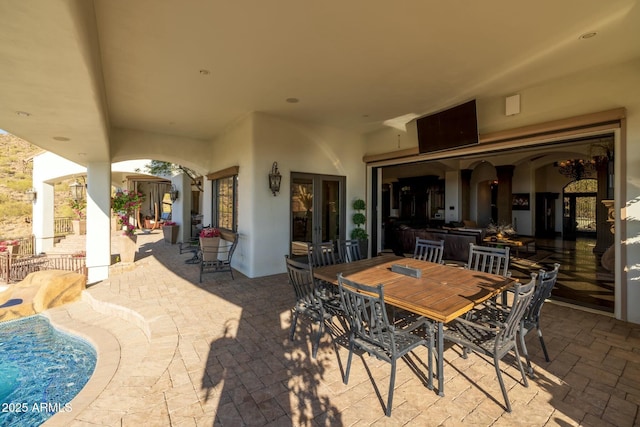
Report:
0,316,96,427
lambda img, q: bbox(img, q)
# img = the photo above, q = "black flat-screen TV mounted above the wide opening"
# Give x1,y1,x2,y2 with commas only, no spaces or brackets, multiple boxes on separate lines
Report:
416,99,479,153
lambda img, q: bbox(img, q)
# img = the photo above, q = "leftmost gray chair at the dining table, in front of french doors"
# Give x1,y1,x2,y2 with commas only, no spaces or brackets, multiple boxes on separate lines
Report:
285,255,332,358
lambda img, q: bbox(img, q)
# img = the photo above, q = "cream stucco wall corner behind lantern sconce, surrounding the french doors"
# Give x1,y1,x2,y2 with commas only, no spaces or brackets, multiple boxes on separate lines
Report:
205,113,365,277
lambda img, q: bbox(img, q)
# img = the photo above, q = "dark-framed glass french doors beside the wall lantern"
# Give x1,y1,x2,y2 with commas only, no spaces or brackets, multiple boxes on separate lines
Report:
290,172,346,256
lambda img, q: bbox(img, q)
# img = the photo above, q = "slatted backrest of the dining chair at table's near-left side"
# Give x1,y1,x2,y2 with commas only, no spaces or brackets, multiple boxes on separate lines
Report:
338,274,396,357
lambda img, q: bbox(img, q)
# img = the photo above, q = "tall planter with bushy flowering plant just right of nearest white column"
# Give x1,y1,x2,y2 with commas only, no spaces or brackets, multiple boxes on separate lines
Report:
111,190,144,262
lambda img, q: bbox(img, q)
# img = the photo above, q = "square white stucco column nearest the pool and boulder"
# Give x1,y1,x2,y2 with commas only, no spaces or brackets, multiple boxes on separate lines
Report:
87,162,111,283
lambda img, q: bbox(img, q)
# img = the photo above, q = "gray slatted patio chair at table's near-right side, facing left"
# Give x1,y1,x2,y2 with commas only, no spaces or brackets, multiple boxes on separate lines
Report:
443,273,537,412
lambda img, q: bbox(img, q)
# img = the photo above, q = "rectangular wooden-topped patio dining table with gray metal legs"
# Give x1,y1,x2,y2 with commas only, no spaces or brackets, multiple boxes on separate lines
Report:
313,255,516,396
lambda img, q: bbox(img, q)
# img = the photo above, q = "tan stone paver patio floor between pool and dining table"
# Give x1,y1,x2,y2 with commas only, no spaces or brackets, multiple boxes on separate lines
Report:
36,232,640,427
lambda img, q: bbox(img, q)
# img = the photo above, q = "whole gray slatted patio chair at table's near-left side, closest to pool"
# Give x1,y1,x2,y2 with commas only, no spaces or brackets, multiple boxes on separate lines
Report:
338,274,433,417
